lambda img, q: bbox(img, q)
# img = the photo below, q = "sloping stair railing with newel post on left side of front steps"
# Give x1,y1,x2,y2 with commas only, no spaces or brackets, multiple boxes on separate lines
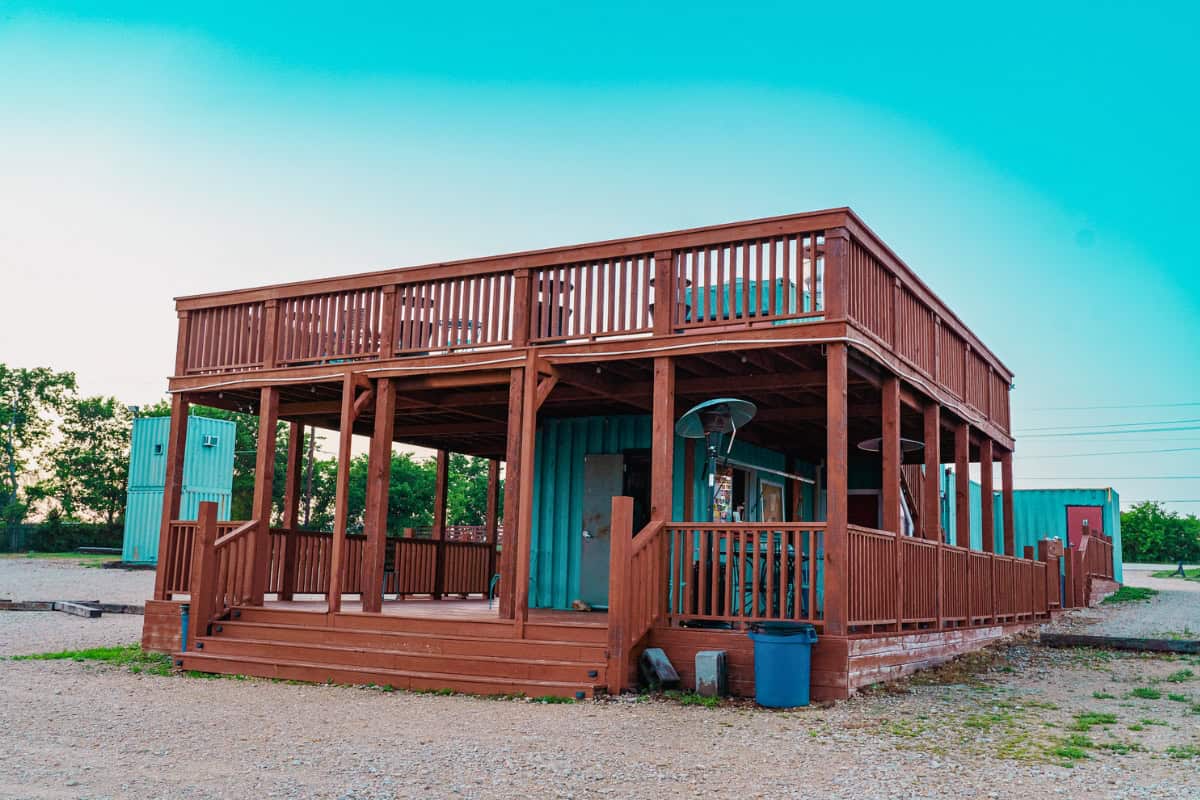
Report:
187,503,258,648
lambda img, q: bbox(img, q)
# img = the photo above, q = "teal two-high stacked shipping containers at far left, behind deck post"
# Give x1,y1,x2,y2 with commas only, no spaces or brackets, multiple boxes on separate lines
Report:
121,416,236,564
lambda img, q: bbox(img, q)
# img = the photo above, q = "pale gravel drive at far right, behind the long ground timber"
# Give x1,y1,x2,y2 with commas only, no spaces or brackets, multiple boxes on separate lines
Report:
1054,565,1200,639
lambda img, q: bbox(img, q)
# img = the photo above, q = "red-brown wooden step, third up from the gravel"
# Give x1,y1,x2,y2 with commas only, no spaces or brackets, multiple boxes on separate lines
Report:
214,620,607,662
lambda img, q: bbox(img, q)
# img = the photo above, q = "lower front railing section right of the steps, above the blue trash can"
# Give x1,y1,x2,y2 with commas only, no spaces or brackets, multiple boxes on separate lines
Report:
665,522,824,627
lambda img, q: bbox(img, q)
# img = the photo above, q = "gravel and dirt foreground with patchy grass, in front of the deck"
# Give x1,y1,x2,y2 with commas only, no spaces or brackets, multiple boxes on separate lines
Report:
0,569,1200,800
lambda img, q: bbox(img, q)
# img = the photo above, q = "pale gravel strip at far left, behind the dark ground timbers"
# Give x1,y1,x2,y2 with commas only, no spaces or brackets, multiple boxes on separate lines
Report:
0,557,154,604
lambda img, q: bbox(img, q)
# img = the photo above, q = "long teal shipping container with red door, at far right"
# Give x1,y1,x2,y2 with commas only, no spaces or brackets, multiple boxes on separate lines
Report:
942,470,1124,583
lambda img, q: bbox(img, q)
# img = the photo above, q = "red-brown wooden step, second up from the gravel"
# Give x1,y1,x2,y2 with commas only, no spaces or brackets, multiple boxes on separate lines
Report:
200,634,605,684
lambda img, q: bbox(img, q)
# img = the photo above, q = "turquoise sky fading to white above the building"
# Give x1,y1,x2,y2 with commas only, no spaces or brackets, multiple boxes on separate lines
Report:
0,0,1200,512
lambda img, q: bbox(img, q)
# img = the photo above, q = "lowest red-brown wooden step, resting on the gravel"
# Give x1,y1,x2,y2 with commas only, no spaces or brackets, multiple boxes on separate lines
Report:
175,651,596,698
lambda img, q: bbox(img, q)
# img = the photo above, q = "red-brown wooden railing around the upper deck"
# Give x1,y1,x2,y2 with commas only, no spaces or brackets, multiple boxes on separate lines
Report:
176,209,1012,431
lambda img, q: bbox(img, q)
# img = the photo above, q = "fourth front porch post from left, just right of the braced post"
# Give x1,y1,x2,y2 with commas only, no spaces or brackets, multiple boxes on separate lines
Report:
362,378,396,614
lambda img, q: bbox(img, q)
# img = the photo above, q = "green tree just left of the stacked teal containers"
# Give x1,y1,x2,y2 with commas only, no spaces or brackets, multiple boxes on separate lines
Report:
30,397,133,525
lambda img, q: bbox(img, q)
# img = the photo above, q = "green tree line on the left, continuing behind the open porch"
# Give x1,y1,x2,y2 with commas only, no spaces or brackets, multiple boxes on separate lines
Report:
0,363,503,531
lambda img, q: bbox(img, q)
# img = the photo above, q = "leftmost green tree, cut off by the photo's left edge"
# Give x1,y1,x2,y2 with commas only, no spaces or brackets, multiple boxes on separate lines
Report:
0,363,76,523
